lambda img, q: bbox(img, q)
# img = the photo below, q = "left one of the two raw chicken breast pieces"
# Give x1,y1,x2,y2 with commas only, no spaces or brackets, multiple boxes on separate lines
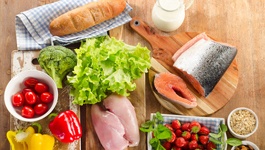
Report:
91,104,129,150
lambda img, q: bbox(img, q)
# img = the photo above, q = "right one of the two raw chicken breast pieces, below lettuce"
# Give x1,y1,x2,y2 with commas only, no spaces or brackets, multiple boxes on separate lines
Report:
103,94,140,147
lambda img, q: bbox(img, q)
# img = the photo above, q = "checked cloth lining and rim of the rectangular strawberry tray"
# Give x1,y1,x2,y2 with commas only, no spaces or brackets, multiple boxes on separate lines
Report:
147,113,227,150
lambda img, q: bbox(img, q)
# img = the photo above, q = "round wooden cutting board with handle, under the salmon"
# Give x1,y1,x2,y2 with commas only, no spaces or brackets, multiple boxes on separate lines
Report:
130,17,238,116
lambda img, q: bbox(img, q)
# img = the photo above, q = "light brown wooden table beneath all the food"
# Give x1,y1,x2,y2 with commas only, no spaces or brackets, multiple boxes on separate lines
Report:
0,0,265,149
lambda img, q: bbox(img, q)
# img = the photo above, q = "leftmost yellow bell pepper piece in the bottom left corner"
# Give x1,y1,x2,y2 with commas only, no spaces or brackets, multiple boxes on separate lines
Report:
6,131,27,150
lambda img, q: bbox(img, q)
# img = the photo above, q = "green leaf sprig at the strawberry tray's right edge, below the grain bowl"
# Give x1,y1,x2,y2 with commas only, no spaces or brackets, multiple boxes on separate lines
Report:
209,124,242,146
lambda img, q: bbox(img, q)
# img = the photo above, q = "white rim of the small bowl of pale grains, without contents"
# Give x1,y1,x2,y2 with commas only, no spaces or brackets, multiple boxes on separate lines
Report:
227,107,259,139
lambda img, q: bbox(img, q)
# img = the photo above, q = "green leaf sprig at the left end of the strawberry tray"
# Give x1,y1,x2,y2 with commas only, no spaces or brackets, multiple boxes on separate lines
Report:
140,112,172,150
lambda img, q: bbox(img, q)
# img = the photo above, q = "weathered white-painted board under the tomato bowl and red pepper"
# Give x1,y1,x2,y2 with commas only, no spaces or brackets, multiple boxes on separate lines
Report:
10,50,81,150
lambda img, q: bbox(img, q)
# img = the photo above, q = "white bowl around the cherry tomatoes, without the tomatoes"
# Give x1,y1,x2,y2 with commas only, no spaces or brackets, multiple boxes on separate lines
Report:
4,70,58,122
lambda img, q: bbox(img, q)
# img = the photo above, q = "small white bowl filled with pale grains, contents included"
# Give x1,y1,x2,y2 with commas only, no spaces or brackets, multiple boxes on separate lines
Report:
227,107,259,139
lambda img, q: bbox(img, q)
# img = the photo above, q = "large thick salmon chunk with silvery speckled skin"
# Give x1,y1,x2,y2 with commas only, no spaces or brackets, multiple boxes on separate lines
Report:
172,33,237,97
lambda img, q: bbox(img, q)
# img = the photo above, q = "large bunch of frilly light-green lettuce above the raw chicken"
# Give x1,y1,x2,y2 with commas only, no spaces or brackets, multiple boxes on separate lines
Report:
68,36,151,105
